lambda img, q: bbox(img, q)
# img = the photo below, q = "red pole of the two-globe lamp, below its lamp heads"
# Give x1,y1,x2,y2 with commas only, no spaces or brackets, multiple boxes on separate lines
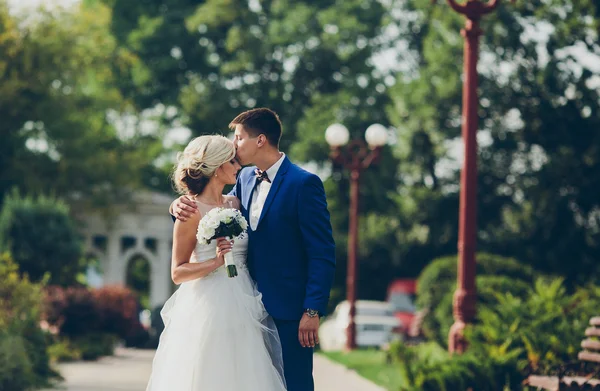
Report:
346,167,360,350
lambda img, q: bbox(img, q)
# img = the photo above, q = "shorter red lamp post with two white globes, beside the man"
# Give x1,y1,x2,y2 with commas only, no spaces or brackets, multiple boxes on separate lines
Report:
325,124,387,350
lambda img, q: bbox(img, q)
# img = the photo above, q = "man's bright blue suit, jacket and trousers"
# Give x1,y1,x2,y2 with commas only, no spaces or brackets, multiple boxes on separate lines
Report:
231,157,335,391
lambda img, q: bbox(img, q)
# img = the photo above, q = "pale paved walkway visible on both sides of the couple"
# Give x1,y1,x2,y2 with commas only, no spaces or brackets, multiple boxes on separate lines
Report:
45,349,384,391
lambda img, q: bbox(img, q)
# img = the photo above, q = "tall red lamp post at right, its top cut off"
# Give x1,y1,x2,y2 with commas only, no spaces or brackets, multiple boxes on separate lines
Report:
438,0,514,353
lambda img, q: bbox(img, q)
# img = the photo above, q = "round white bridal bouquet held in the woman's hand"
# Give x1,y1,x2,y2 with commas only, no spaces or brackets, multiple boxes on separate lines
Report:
198,208,248,277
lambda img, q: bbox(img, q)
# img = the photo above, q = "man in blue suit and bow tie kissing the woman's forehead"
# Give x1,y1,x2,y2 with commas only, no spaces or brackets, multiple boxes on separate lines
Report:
173,108,335,391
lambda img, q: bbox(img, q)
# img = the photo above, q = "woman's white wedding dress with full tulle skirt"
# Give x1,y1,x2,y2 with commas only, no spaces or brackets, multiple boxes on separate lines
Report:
147,204,286,391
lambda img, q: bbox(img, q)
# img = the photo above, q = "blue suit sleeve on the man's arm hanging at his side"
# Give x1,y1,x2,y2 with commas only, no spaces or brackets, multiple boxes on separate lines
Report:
298,175,335,314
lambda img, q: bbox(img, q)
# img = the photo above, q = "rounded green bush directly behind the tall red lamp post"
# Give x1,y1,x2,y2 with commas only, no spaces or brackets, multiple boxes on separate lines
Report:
417,253,533,346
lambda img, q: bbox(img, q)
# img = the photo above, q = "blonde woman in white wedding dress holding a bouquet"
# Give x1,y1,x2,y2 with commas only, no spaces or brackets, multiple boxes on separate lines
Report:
147,136,286,391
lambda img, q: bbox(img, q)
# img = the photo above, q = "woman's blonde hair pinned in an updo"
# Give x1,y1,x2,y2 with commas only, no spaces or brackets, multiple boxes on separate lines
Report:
173,136,235,195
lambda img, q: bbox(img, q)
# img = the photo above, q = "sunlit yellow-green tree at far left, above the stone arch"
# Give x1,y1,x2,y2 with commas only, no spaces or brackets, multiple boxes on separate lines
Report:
0,1,160,205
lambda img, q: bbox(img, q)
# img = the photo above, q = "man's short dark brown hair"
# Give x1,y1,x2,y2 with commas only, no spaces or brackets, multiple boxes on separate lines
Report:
229,107,282,148
